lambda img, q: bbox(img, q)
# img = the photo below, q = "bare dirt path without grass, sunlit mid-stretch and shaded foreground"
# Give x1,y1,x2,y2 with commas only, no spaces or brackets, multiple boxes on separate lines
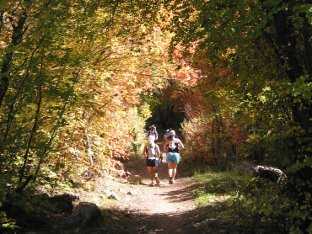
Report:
73,159,254,234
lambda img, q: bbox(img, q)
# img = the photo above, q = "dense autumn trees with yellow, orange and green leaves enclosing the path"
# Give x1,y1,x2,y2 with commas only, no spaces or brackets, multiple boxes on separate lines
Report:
0,0,312,234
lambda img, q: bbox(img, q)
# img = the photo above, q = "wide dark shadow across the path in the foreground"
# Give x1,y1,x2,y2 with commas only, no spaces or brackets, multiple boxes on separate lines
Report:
15,206,255,234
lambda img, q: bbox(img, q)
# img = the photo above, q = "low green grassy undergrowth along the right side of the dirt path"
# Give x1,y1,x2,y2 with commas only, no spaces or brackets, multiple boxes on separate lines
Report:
194,170,296,233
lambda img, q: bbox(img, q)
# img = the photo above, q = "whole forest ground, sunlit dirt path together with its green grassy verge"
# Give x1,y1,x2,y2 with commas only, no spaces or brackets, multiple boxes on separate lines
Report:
11,158,281,234
